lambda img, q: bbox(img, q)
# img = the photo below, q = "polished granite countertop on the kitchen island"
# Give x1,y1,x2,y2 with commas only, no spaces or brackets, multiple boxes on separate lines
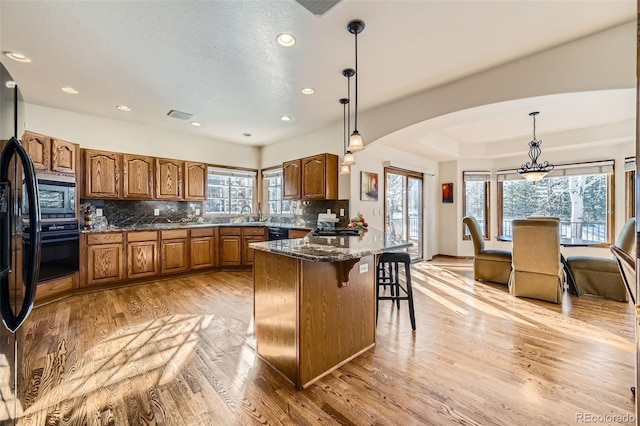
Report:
249,228,413,262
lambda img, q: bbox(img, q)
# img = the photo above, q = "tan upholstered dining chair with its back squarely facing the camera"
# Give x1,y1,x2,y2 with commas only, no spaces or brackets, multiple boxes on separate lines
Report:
509,219,564,303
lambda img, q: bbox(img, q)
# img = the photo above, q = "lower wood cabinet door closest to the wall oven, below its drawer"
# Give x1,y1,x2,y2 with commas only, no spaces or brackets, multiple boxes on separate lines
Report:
87,244,124,285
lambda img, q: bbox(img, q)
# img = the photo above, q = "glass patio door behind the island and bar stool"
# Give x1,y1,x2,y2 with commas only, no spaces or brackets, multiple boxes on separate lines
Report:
384,168,423,260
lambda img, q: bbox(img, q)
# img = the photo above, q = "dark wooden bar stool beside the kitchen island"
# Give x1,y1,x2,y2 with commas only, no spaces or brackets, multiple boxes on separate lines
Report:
376,252,416,331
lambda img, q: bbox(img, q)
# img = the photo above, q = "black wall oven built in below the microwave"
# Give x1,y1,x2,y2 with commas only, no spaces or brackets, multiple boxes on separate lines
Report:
22,221,80,282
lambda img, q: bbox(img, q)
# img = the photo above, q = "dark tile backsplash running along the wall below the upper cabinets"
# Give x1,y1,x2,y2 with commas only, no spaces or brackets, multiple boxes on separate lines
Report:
80,199,349,228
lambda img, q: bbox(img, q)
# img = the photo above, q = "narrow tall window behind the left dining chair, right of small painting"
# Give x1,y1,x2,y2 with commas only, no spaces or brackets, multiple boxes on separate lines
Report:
462,172,491,240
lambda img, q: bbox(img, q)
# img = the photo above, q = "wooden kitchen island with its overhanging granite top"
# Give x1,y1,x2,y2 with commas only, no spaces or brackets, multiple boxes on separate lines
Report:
250,229,411,389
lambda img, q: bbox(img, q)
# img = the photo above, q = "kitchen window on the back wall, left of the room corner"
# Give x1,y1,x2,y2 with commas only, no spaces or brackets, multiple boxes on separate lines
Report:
205,167,256,214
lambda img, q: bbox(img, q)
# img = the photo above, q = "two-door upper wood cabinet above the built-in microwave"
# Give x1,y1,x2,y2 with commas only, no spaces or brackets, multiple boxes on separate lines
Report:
22,131,79,175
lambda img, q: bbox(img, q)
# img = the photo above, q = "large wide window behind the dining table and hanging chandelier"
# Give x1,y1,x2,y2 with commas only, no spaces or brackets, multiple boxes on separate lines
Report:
498,161,614,243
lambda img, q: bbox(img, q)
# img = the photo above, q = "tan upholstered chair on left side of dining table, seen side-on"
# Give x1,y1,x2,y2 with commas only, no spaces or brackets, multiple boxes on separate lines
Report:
462,216,511,284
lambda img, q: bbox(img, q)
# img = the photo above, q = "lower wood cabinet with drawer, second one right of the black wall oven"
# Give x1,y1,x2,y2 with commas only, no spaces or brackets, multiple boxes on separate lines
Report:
127,231,159,279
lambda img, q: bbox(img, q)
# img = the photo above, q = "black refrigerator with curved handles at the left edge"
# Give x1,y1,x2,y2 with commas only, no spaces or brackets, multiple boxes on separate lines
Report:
0,63,41,425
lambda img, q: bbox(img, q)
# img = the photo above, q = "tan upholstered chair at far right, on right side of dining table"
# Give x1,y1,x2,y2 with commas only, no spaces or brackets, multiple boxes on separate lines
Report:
567,217,636,302
